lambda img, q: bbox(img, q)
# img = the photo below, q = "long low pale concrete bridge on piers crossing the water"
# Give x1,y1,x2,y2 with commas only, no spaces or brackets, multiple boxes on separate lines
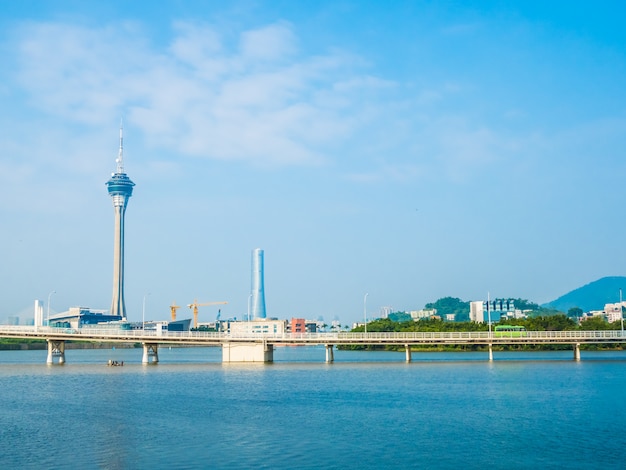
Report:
0,325,626,364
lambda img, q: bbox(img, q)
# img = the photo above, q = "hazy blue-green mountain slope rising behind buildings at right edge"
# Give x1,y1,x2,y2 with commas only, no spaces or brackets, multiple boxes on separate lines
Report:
542,276,626,313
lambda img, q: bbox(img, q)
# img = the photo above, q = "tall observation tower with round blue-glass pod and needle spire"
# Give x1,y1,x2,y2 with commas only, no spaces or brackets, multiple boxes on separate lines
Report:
106,125,135,320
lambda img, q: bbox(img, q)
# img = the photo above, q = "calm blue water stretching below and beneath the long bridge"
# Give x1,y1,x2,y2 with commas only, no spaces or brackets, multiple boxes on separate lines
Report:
0,347,626,469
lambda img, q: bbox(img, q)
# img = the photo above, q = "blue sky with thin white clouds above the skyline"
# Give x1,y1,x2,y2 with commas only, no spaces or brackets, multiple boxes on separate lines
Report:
0,0,626,324
